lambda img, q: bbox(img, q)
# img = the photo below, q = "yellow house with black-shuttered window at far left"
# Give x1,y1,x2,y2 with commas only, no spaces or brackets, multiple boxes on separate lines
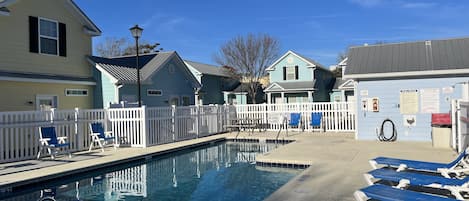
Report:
0,0,101,111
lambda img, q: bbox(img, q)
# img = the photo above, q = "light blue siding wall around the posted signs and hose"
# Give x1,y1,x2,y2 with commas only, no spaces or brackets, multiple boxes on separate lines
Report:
356,77,469,141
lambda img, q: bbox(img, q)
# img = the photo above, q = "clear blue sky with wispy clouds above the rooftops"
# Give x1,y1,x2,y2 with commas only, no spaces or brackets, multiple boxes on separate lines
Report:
75,0,469,66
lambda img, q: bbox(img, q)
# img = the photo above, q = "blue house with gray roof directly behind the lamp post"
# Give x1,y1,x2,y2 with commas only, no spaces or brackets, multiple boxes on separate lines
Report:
89,51,200,108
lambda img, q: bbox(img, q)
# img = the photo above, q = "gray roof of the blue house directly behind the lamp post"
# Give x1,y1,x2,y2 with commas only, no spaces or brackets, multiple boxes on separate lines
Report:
90,51,176,83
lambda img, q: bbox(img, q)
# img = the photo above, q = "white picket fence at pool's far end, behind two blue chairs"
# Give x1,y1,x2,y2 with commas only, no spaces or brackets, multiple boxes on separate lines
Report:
236,102,356,132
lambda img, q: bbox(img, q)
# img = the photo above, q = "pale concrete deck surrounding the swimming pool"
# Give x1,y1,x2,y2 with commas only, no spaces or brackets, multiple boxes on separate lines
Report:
0,132,457,201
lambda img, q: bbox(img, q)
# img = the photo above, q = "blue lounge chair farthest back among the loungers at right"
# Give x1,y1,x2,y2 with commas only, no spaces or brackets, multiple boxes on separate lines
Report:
370,149,469,178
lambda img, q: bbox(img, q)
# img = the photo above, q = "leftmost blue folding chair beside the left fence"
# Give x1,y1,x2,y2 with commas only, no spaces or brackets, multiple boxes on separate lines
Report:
37,127,72,159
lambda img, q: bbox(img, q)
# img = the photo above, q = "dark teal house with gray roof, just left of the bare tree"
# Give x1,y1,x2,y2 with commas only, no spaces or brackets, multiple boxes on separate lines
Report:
184,60,239,105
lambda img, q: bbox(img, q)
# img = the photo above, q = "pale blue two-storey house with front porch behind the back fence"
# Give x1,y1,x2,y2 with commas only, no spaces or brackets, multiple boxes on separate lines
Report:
264,51,335,103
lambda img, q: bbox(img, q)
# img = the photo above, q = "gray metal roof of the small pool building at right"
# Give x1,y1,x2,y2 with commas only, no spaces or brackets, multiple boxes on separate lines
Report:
345,38,469,78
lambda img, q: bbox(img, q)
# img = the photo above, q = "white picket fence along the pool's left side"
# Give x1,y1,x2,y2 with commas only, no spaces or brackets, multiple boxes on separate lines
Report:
0,105,234,163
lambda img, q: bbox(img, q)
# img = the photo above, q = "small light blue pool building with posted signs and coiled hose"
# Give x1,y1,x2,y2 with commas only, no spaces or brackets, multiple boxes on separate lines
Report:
345,38,469,141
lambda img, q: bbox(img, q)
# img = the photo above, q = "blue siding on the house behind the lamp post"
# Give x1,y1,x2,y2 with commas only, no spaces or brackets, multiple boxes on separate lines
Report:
119,57,195,107
